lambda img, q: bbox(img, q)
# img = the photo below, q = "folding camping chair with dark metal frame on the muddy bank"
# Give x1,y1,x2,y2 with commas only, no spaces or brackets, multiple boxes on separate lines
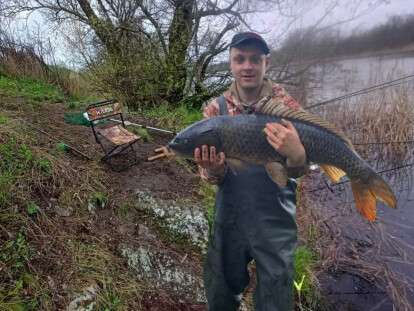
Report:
86,99,141,172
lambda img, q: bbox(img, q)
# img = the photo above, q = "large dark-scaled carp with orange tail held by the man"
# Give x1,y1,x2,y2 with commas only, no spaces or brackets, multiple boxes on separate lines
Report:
169,98,396,221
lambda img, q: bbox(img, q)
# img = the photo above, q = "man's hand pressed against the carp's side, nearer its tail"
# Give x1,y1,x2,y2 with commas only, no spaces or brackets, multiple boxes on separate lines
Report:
264,119,306,167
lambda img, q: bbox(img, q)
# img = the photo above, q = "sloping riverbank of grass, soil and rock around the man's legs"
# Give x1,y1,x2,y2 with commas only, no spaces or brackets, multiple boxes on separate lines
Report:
0,72,412,311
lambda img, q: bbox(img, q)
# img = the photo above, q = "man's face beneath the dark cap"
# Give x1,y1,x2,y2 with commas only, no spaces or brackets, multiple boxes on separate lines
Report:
230,45,269,91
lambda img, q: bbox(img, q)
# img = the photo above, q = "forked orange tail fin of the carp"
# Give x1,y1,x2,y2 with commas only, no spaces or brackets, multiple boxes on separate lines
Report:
351,172,397,221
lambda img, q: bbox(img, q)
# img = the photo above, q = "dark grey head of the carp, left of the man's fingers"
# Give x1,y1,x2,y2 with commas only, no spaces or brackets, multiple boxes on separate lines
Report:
168,119,221,158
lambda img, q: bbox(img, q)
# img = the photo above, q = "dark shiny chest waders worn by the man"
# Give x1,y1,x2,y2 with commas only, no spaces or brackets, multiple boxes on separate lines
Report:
204,96,297,311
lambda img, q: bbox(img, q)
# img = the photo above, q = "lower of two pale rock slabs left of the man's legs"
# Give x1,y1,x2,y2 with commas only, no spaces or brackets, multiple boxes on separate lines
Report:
120,245,206,303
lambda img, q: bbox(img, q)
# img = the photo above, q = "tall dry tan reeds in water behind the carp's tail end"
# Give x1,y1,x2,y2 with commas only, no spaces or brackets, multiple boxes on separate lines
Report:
316,81,414,168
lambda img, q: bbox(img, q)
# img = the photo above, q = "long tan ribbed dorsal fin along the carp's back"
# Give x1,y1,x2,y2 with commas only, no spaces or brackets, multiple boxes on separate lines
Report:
255,96,354,150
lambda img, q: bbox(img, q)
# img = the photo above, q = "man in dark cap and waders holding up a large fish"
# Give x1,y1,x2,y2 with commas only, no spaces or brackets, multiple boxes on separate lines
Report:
194,32,307,311
